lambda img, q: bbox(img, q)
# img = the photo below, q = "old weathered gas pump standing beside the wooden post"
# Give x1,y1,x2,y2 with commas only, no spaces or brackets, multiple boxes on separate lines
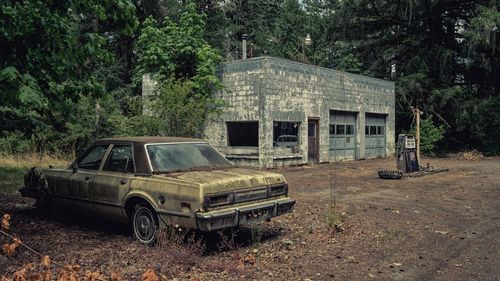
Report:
396,134,419,173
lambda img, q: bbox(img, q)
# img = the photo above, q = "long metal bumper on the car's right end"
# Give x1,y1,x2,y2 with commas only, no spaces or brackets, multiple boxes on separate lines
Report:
196,198,295,231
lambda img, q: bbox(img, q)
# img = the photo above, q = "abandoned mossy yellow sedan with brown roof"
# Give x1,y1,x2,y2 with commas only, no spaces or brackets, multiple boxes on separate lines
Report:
21,137,295,244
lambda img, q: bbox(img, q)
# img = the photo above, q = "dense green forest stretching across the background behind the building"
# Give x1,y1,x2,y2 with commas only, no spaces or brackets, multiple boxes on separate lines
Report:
0,0,500,154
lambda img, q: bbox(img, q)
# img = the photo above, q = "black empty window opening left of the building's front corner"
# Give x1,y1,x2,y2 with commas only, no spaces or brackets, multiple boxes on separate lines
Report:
226,121,259,147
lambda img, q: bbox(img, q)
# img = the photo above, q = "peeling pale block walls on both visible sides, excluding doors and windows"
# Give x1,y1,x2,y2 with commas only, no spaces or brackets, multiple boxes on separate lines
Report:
195,57,395,167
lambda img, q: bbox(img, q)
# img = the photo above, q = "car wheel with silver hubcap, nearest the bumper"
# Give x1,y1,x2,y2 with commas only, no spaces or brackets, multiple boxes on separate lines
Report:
131,202,158,246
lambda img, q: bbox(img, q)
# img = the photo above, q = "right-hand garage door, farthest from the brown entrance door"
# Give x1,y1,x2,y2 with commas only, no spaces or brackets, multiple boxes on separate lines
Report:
365,113,386,158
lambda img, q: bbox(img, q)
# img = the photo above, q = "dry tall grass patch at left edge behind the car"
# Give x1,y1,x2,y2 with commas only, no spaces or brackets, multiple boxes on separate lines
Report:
0,153,71,193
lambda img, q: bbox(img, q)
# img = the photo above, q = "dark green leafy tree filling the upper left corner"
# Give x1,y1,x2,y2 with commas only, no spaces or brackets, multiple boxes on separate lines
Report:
0,0,137,152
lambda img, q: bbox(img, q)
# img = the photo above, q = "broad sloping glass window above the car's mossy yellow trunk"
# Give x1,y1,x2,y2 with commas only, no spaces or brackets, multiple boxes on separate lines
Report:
146,143,232,173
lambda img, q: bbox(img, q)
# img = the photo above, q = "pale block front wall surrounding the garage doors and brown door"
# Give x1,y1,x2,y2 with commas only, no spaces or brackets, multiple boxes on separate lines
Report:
259,57,395,167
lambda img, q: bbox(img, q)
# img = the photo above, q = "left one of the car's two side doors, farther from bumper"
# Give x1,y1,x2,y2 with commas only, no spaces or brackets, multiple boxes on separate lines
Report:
54,145,109,213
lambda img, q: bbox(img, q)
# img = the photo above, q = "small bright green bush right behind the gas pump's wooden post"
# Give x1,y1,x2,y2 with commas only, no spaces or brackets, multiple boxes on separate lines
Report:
411,116,446,155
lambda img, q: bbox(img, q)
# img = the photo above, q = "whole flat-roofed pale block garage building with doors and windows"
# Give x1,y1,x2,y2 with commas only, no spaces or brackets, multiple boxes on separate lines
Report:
204,57,395,168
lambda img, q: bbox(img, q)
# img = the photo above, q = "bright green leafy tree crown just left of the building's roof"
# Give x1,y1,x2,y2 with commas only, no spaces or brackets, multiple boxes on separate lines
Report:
136,4,221,92
